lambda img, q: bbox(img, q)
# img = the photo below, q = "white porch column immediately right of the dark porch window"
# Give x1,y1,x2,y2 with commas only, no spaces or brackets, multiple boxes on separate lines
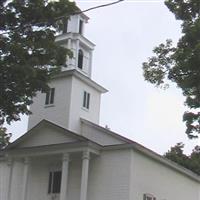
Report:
60,153,69,200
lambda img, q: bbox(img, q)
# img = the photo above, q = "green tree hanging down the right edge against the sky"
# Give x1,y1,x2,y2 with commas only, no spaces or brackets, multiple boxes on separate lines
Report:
143,0,200,138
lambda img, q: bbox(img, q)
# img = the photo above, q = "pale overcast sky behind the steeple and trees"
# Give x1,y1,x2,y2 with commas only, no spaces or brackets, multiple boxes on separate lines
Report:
9,0,199,154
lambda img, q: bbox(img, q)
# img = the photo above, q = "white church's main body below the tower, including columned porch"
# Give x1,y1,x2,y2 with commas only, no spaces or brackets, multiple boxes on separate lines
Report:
0,120,200,200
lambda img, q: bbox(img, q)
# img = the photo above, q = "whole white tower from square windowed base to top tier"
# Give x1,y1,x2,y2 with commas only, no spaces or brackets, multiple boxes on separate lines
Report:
28,13,107,134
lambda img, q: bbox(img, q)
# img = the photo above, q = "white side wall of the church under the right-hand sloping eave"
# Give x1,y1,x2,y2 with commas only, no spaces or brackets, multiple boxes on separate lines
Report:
130,151,200,200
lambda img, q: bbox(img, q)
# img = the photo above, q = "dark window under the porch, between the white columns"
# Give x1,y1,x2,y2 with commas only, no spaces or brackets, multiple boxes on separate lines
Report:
48,171,62,194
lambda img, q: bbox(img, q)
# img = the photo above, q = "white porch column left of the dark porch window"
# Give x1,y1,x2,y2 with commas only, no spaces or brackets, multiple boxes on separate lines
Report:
22,158,29,200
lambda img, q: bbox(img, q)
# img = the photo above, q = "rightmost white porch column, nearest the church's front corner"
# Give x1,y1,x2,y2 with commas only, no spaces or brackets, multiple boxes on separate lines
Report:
80,151,90,200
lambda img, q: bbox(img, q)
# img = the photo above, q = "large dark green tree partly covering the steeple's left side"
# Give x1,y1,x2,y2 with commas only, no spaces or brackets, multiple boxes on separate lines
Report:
0,0,79,146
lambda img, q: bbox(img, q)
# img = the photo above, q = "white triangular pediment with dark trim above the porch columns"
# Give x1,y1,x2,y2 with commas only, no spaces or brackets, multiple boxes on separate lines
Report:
7,120,86,148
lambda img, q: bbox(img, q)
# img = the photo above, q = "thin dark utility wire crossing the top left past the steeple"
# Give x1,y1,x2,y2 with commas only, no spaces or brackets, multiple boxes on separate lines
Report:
0,0,125,35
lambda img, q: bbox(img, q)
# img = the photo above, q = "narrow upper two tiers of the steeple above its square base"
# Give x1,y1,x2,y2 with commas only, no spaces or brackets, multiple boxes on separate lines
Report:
56,14,95,77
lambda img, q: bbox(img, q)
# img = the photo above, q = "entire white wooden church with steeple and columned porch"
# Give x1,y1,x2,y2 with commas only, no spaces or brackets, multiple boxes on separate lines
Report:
0,14,200,200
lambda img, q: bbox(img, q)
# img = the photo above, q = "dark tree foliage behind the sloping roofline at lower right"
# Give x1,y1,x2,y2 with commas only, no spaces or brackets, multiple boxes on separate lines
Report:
164,143,200,175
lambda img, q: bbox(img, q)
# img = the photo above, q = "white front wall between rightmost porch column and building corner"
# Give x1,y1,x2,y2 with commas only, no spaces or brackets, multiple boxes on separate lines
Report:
88,150,131,200
